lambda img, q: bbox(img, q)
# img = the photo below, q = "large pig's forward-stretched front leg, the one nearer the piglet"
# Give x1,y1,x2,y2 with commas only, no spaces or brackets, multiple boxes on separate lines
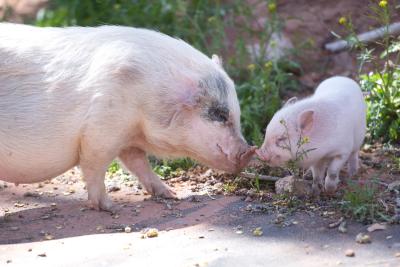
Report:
119,148,176,198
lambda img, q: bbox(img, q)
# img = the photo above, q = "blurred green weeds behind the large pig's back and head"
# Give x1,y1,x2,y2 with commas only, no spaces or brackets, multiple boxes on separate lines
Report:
34,0,298,145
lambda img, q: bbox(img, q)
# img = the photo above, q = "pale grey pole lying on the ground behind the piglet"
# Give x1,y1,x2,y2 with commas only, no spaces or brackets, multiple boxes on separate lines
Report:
325,22,400,52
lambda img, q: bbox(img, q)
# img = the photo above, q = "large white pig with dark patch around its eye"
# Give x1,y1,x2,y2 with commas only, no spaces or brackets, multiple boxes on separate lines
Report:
0,23,254,210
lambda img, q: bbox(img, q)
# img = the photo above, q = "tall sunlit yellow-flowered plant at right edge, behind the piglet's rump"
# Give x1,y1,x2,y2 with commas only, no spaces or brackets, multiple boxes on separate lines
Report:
339,1,400,142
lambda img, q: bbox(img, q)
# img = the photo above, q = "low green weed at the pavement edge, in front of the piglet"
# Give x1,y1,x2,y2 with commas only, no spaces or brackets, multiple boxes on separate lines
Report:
340,181,390,223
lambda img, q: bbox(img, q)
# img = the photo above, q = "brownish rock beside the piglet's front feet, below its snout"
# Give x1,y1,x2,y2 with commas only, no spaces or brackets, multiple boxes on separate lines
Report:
275,176,312,197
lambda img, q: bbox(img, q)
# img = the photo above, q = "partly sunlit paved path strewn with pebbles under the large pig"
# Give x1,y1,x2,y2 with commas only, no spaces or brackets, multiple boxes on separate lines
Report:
0,173,400,266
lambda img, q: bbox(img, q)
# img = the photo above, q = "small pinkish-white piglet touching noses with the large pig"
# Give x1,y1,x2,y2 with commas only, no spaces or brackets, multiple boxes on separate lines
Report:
256,77,366,194
